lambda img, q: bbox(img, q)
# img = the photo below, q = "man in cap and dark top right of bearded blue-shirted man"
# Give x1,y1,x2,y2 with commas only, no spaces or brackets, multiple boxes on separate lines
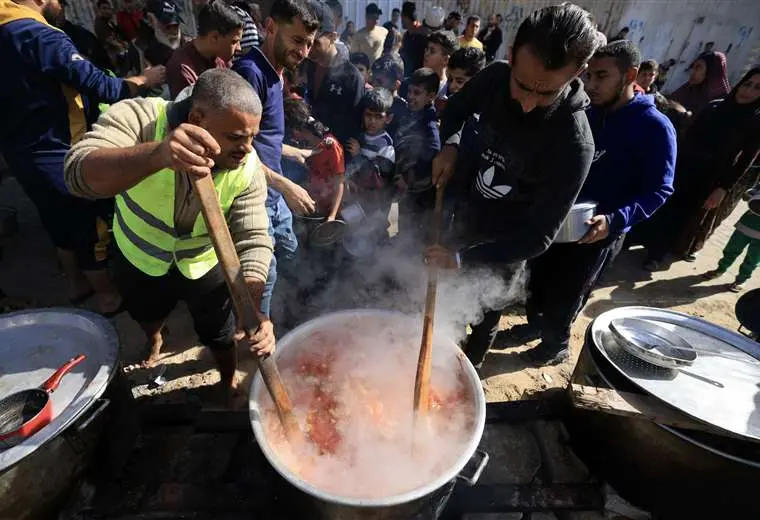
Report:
305,0,364,144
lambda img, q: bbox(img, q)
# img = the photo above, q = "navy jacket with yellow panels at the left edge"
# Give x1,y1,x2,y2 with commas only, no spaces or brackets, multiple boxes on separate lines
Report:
0,0,130,193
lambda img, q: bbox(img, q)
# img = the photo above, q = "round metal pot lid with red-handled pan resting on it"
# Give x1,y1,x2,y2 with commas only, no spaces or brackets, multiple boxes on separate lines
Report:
0,309,119,473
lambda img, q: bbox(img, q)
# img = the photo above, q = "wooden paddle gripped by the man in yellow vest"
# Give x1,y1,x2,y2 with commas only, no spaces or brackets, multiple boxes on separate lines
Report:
190,175,298,433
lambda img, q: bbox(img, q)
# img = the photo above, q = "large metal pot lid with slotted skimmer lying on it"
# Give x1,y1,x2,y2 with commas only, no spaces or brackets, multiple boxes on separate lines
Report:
591,307,760,440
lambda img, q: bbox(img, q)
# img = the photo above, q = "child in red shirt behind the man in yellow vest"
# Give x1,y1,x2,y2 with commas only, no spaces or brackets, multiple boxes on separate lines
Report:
283,98,346,221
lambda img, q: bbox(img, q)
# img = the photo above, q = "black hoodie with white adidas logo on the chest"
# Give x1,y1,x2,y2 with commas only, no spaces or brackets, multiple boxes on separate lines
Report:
441,61,594,264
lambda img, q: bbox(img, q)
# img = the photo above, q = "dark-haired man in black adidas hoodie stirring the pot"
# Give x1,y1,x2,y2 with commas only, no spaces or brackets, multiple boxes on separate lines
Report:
427,4,603,366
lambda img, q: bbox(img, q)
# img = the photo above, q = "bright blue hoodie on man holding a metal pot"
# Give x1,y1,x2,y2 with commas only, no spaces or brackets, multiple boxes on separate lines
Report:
578,94,676,236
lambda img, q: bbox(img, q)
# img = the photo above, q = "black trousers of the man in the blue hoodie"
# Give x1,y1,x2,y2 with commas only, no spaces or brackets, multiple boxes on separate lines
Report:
525,236,625,348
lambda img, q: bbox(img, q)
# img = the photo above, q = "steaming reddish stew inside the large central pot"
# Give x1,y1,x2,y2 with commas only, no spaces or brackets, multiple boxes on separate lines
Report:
260,322,474,498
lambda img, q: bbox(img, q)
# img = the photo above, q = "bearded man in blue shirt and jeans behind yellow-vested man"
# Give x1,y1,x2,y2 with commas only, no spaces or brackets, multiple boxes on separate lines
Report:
233,0,319,314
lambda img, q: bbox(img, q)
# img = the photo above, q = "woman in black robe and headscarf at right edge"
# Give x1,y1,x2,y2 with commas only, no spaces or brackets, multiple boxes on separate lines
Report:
644,67,760,271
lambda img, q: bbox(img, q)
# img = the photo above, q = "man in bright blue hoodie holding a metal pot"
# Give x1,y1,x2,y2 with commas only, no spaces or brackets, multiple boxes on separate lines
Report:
510,40,676,364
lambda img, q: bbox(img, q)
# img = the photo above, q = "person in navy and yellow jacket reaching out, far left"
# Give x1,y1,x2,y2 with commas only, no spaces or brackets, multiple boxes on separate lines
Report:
0,0,165,314
